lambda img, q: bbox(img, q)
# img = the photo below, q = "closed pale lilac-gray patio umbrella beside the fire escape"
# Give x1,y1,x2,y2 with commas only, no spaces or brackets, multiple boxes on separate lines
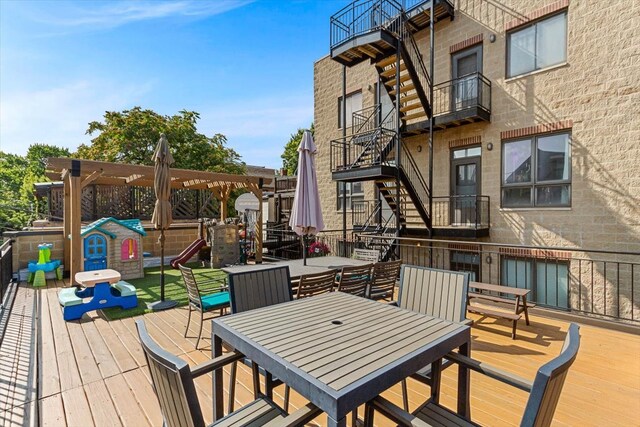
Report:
289,130,324,265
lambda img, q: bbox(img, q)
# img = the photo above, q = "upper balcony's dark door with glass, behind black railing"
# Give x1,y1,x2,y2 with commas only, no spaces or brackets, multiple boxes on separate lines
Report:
451,45,482,111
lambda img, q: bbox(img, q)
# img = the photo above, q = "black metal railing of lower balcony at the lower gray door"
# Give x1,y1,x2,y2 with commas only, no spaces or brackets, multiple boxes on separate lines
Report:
433,195,490,230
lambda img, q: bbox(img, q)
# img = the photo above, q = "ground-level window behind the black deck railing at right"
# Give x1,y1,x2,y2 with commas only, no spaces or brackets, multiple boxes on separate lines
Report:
500,255,569,308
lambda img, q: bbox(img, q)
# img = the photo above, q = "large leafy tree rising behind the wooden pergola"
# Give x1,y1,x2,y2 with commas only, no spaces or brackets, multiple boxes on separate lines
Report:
76,107,244,173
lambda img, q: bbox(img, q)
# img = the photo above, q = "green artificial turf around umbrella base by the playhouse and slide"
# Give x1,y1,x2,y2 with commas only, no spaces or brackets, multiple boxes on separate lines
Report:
102,265,226,320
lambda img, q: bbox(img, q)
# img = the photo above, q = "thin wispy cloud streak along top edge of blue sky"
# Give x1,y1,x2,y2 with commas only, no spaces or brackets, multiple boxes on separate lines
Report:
25,0,254,29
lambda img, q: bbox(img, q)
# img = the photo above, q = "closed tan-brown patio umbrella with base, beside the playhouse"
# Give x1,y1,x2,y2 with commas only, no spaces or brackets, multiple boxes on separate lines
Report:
149,134,178,311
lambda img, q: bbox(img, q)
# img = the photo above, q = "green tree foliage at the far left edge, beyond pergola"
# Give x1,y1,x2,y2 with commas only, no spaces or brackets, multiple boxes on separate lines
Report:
0,144,70,233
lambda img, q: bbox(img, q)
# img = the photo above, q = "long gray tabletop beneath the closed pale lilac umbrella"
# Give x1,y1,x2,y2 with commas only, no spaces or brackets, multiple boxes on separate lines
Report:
221,256,371,280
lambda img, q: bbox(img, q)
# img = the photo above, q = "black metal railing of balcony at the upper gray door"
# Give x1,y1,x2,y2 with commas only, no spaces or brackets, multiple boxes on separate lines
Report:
433,73,491,116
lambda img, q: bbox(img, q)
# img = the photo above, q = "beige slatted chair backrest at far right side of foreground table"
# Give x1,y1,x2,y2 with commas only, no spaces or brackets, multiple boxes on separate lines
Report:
398,265,469,322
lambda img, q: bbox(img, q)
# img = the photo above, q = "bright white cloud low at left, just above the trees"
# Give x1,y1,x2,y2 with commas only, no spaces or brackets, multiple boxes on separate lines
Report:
0,80,153,154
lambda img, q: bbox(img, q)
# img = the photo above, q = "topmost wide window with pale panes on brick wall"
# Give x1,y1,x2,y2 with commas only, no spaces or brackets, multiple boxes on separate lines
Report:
507,11,567,77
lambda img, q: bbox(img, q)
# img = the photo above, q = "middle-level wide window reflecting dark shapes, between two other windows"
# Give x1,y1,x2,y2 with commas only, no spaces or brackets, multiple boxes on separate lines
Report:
502,133,571,207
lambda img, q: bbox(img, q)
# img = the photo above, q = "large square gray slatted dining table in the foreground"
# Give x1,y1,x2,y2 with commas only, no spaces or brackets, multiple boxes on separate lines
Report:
212,292,471,426
